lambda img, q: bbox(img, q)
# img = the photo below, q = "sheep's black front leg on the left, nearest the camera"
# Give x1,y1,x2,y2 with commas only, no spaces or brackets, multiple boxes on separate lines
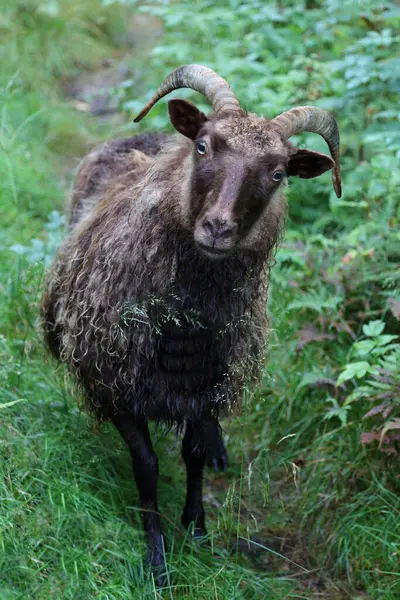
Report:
112,413,164,570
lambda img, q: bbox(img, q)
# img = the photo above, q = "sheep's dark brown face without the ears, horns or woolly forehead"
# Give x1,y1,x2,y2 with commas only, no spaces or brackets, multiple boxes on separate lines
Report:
191,123,288,258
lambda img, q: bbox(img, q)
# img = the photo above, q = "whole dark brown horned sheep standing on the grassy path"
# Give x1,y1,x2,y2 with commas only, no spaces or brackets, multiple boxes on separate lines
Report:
41,65,341,571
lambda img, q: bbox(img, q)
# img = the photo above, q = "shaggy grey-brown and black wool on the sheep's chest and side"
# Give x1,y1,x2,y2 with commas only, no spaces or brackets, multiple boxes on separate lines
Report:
42,134,284,424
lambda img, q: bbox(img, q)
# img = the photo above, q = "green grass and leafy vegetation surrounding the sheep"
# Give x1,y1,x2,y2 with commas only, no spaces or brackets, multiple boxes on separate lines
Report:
0,0,400,600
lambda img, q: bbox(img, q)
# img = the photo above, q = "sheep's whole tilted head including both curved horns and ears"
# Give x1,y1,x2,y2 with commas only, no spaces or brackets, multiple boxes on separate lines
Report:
135,65,341,258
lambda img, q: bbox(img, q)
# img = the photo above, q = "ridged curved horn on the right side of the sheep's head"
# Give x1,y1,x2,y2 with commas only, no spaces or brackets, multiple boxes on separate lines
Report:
270,106,342,198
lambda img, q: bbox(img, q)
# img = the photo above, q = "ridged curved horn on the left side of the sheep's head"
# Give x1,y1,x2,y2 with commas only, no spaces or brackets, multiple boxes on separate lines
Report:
134,65,240,123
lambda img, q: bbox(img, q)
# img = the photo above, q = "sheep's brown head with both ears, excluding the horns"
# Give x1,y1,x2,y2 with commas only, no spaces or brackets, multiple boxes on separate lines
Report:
169,100,333,258
